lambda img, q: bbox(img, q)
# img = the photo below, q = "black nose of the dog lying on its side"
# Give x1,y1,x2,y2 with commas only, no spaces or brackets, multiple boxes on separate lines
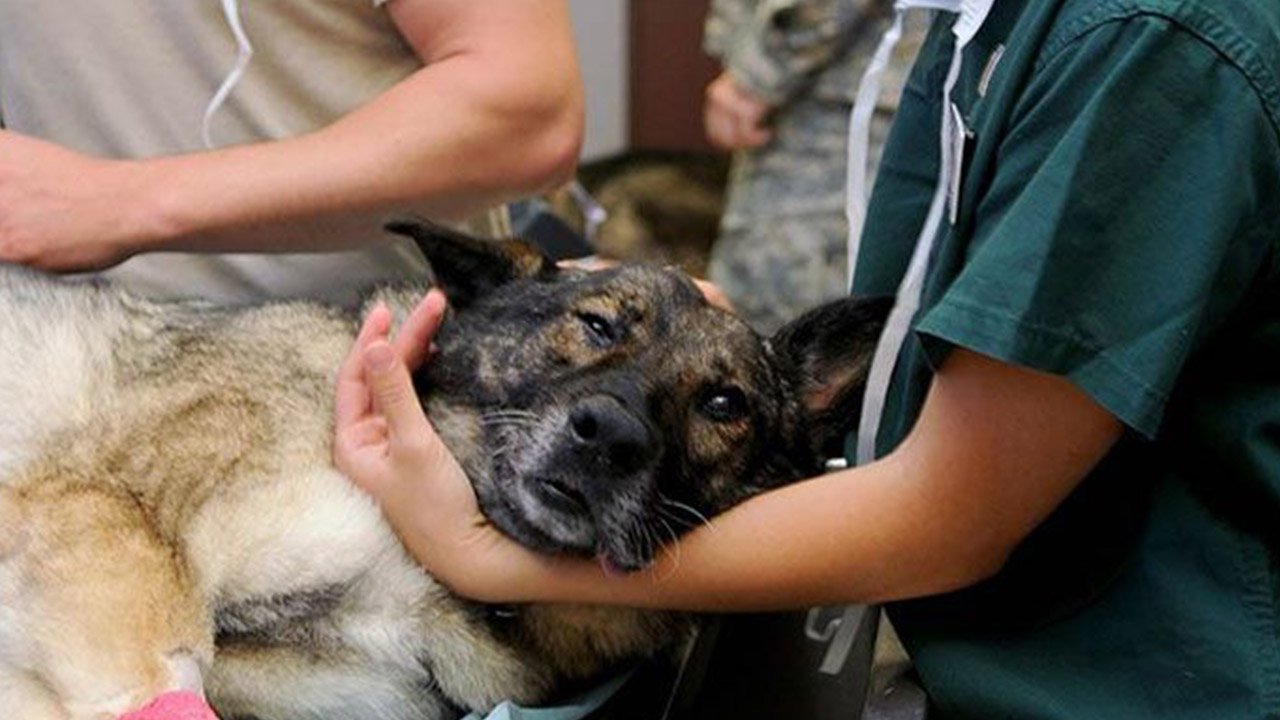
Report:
568,395,653,471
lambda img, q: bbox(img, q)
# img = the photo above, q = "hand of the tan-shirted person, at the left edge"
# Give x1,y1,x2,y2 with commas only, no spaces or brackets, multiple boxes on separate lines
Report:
0,129,156,272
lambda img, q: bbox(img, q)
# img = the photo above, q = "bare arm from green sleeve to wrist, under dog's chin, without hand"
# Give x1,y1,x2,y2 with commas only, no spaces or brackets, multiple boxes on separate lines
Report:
481,351,1121,610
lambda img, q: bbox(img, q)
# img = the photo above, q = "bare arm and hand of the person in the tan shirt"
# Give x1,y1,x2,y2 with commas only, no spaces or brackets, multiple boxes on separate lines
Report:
0,0,581,269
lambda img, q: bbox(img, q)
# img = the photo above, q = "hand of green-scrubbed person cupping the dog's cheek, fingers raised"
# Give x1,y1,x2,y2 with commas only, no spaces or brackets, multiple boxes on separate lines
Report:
333,290,541,602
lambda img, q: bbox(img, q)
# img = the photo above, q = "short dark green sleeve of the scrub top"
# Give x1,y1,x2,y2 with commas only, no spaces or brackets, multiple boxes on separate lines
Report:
916,17,1280,437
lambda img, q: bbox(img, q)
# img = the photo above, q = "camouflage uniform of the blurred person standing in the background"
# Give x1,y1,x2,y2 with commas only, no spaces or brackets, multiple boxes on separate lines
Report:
704,0,924,332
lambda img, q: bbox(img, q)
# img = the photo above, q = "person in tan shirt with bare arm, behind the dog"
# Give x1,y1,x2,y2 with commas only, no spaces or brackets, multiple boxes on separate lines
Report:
0,0,582,304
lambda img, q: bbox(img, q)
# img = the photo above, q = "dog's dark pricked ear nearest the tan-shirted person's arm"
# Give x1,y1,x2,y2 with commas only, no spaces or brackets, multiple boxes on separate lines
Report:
385,219,559,307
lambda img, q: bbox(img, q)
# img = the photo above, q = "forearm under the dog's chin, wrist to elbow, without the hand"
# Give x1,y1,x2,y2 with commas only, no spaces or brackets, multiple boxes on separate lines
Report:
504,450,1002,610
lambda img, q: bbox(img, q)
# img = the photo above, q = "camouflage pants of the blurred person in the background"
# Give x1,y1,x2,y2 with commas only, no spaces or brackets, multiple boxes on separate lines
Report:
709,7,932,332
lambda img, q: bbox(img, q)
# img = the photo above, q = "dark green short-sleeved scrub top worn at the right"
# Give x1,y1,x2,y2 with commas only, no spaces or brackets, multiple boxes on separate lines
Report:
854,0,1280,720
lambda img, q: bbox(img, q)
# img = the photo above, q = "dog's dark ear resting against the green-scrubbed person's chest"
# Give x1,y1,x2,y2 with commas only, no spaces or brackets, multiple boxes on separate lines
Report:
769,297,893,454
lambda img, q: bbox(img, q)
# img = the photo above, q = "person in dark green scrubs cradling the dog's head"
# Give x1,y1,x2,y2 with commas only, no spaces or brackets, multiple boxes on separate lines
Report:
337,0,1280,720
